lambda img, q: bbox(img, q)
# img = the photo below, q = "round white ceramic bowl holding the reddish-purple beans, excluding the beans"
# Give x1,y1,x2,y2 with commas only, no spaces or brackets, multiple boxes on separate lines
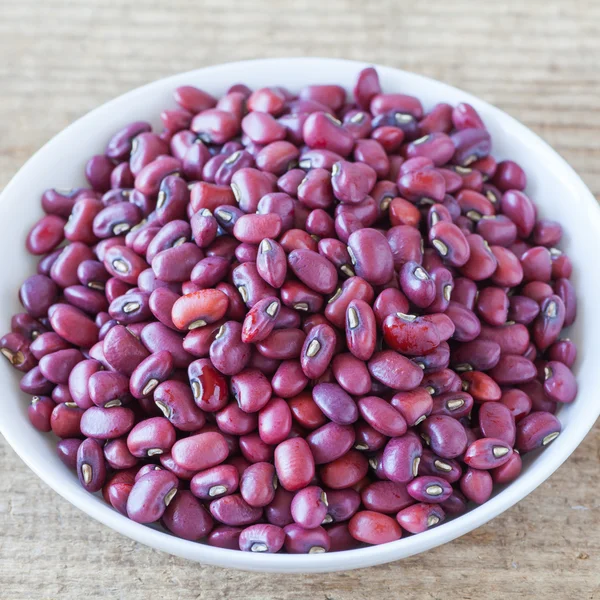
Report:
0,58,600,572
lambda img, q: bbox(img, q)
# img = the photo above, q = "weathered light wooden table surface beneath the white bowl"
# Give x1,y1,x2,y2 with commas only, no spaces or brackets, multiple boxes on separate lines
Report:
0,0,600,600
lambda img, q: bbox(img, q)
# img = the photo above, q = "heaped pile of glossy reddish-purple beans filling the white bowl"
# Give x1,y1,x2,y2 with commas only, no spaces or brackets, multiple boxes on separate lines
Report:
0,68,577,553
